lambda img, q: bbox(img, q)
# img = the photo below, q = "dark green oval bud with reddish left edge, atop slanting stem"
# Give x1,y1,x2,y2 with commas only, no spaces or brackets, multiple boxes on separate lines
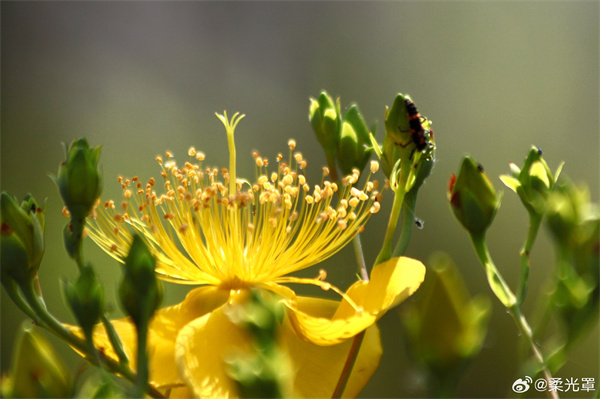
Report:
448,155,500,234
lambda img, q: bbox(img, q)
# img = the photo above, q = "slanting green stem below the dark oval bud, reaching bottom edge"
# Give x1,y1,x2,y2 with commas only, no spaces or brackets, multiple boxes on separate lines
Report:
471,233,558,398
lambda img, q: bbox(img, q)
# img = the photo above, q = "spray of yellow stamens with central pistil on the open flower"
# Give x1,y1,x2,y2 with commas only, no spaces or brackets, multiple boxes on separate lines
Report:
89,113,380,294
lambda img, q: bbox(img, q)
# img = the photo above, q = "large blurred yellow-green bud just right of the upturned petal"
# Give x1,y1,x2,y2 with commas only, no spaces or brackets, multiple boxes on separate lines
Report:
403,253,491,378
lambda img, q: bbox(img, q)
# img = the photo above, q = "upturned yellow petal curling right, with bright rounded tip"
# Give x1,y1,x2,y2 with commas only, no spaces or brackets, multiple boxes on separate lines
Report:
279,257,425,345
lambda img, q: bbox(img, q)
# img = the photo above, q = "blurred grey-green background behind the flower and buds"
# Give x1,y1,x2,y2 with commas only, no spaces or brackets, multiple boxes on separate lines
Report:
1,1,599,397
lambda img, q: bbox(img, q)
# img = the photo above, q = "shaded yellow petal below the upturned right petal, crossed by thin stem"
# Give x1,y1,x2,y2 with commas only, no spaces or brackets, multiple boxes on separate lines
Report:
282,297,382,398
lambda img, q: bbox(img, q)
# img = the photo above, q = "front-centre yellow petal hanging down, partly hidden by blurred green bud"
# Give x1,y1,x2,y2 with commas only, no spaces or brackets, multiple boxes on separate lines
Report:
175,292,250,398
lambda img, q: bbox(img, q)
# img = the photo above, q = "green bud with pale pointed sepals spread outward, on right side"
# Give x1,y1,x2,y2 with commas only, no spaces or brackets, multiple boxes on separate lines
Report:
500,147,563,216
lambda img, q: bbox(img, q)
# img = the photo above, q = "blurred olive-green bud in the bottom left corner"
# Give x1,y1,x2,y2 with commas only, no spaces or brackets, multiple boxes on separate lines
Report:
2,328,70,398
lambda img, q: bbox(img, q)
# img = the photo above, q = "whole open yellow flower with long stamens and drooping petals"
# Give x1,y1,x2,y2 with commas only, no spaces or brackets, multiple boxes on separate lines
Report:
82,113,425,398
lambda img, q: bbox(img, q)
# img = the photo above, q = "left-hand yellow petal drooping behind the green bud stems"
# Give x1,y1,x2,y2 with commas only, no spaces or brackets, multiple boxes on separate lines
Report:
69,286,229,388
